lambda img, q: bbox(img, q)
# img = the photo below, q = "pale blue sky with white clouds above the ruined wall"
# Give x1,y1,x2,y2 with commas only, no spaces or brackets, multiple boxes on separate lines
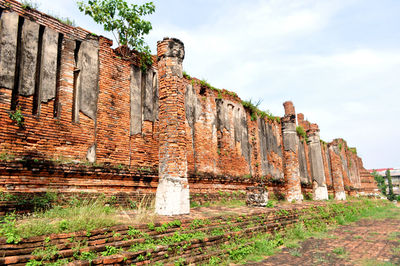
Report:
28,0,400,169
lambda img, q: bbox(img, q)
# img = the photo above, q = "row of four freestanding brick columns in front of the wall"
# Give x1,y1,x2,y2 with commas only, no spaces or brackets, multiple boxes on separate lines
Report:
156,38,345,215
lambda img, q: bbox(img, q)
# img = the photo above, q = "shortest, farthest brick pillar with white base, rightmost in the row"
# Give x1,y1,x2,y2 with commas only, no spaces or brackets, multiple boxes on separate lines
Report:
328,142,346,200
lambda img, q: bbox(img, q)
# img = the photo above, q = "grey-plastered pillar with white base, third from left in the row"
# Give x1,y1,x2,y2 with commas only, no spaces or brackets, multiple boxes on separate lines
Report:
307,124,328,200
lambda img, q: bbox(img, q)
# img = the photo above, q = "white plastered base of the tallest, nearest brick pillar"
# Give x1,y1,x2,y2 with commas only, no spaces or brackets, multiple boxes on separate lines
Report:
156,177,190,215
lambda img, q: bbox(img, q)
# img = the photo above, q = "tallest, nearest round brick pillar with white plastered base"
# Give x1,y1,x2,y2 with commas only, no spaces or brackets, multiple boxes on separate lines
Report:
156,38,190,215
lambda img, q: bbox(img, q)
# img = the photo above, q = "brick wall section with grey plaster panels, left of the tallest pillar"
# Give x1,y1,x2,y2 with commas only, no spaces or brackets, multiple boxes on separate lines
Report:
0,1,158,170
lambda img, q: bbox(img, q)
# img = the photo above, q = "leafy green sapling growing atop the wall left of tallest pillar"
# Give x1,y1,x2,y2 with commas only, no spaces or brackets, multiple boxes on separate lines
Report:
78,0,155,70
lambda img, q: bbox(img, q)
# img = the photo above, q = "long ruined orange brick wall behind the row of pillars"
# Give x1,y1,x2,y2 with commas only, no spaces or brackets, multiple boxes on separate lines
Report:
0,0,374,197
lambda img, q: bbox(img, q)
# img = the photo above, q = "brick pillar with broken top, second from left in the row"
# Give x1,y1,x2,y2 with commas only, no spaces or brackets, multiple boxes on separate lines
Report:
282,102,303,201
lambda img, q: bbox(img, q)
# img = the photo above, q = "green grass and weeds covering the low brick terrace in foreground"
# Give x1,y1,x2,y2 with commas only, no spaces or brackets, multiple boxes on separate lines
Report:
2,196,397,265
